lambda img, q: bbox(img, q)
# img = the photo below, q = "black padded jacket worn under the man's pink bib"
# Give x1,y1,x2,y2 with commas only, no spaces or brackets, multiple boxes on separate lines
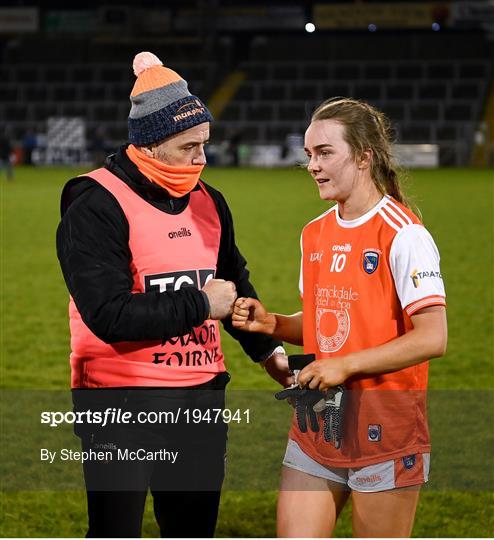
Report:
57,147,281,361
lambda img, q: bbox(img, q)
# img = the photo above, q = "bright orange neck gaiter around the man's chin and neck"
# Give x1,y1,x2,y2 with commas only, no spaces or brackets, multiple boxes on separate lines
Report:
126,144,204,197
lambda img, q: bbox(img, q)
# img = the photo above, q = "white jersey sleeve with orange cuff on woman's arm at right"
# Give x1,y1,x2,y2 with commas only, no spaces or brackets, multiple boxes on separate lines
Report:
389,224,446,315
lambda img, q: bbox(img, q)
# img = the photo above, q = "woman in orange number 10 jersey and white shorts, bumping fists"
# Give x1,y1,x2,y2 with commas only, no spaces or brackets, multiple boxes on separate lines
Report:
233,98,447,537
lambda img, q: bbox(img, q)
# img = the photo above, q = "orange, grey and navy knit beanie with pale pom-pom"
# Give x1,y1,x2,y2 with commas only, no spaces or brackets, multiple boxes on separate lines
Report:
128,52,213,146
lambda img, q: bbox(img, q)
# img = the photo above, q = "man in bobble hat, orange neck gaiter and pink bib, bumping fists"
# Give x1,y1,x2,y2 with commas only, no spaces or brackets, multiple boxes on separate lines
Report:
57,52,292,537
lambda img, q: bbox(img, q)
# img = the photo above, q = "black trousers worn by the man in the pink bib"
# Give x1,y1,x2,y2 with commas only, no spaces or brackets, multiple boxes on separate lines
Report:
72,373,230,538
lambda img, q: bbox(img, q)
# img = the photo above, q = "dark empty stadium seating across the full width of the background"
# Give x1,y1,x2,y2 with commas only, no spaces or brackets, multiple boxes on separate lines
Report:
0,8,493,165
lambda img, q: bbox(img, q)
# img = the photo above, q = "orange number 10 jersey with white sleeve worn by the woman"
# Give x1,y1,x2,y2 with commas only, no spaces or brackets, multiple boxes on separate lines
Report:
290,196,445,467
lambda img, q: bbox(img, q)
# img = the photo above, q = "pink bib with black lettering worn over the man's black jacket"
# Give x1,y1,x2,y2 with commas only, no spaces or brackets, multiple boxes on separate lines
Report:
69,168,225,388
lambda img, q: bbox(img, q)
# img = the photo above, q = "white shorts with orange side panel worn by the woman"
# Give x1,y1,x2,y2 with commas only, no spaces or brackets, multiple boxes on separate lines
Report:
283,439,430,493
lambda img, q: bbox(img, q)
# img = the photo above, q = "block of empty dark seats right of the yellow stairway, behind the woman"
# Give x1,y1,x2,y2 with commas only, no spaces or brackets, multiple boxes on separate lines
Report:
215,33,493,165
